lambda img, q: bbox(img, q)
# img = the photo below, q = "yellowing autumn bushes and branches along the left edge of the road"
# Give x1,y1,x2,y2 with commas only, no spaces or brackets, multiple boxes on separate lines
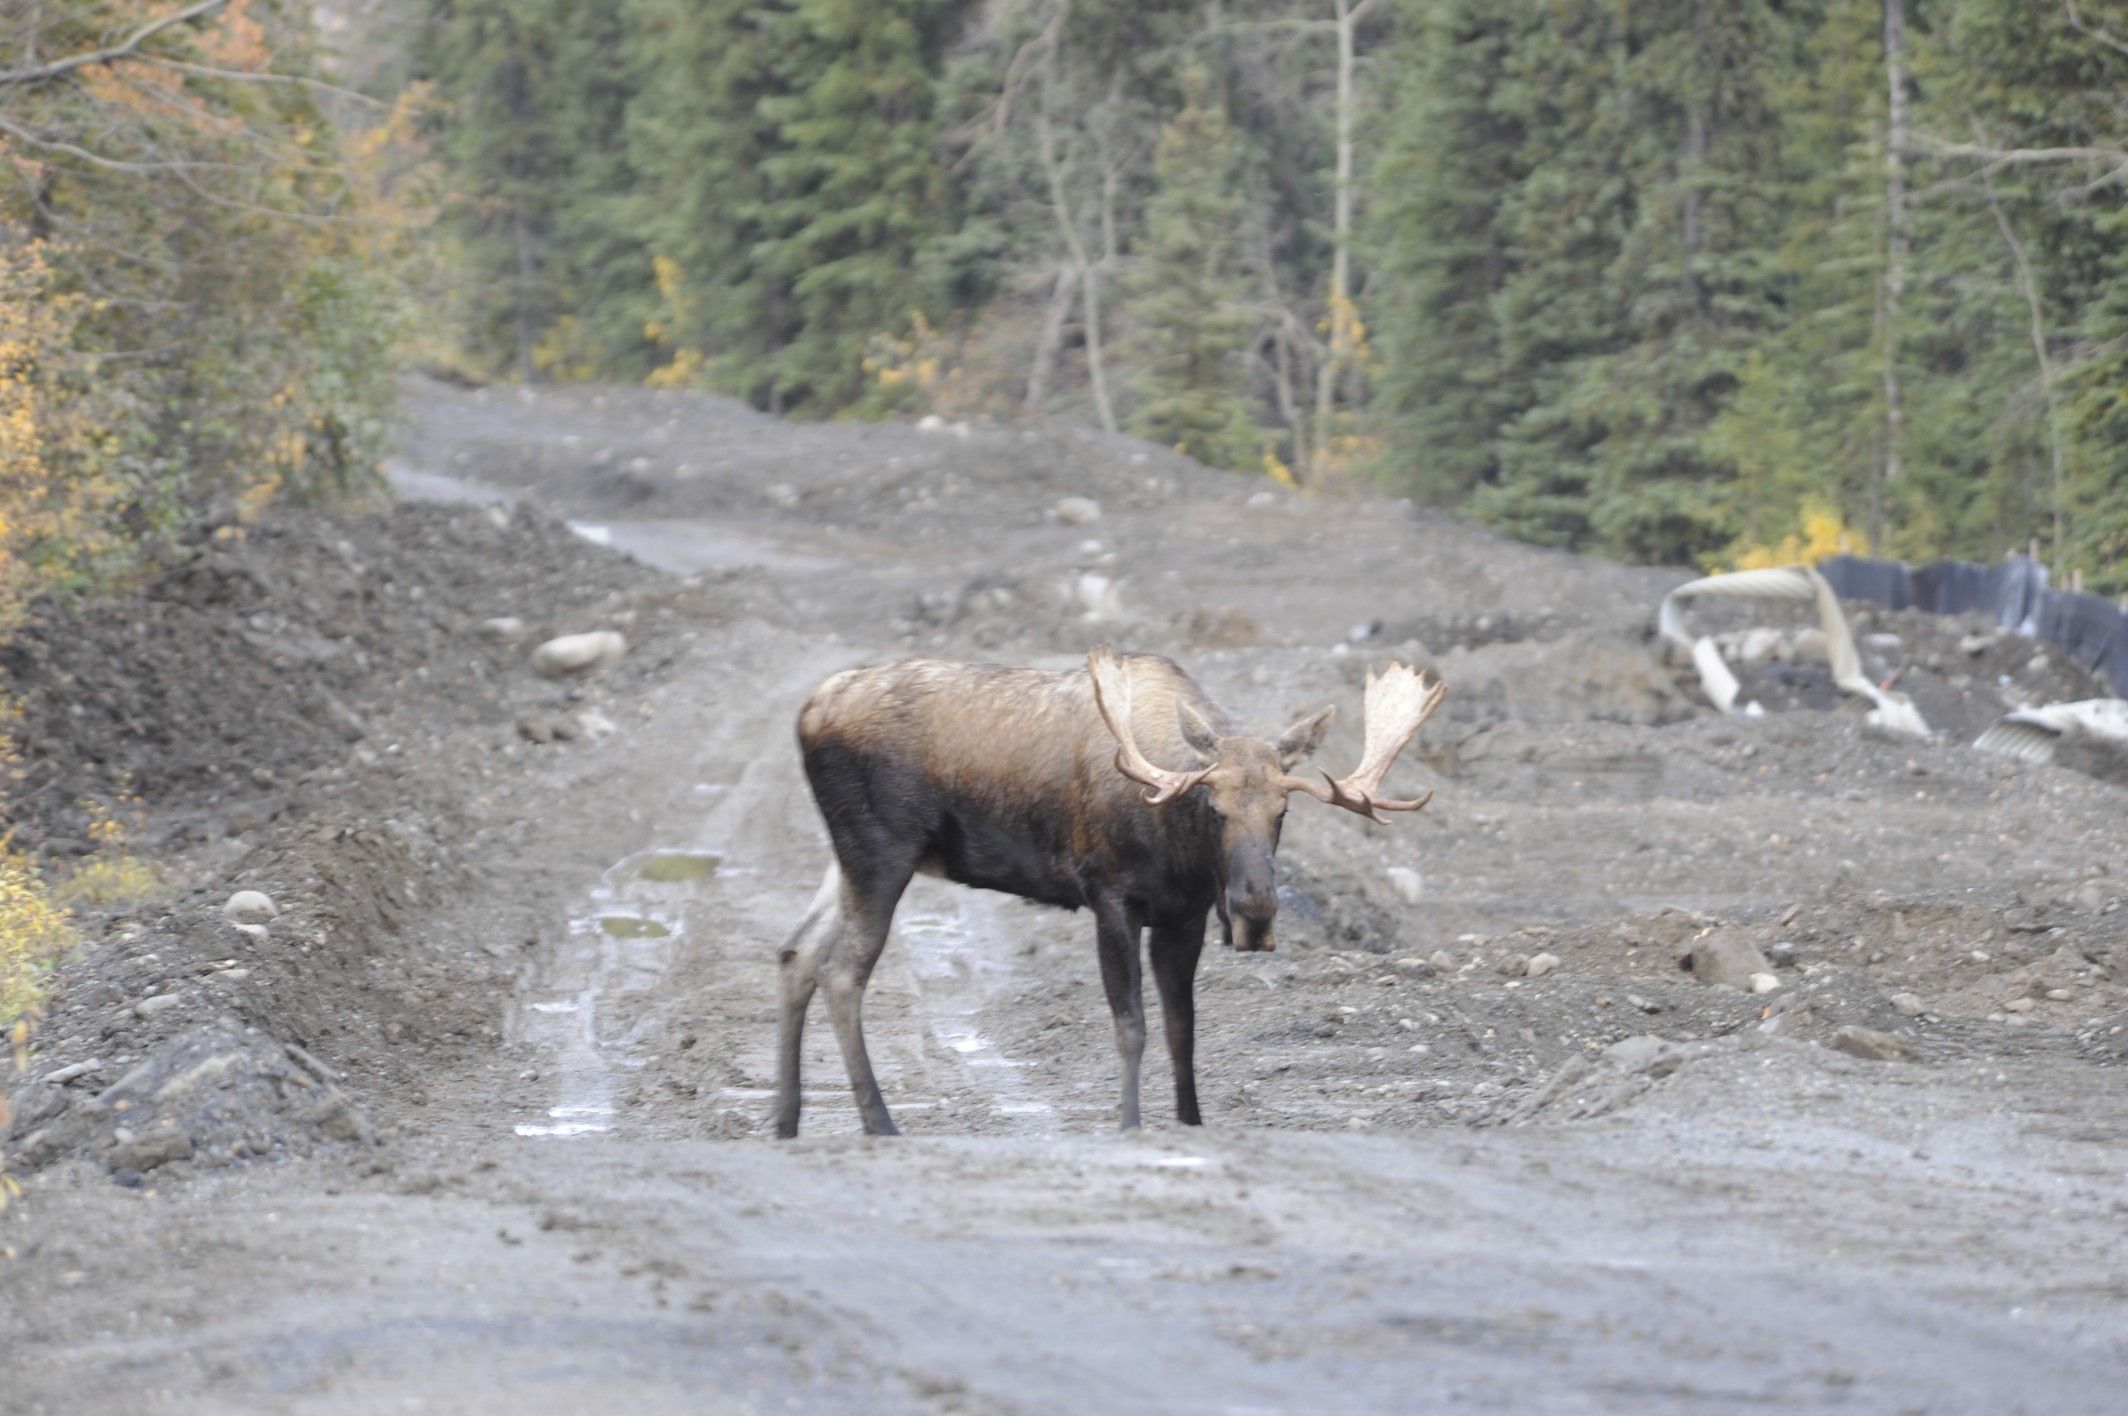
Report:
0,0,430,1199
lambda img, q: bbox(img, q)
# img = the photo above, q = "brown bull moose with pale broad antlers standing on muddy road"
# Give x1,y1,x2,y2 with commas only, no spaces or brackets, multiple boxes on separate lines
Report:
777,647,1447,1137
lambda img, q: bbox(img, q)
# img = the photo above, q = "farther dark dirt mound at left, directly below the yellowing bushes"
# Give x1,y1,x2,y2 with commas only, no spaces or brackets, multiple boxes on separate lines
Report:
0,505,651,854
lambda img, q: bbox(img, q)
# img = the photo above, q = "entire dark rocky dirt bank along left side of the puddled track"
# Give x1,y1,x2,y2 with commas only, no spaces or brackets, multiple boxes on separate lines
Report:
9,505,717,1175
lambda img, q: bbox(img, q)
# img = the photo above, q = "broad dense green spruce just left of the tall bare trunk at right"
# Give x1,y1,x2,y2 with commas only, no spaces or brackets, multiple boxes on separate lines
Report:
1475,0,1800,562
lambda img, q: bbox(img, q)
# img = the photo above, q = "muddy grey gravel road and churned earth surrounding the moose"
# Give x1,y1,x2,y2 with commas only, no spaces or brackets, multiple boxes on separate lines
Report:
0,385,2128,1412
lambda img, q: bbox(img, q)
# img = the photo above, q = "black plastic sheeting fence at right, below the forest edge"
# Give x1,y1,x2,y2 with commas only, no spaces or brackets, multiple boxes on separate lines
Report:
1817,556,2128,698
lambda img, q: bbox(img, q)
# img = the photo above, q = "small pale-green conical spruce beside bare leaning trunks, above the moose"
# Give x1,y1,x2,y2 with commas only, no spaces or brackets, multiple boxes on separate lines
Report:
1128,68,1260,468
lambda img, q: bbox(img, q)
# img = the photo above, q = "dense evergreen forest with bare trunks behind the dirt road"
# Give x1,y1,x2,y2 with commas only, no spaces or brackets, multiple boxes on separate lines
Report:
406,0,2128,590
